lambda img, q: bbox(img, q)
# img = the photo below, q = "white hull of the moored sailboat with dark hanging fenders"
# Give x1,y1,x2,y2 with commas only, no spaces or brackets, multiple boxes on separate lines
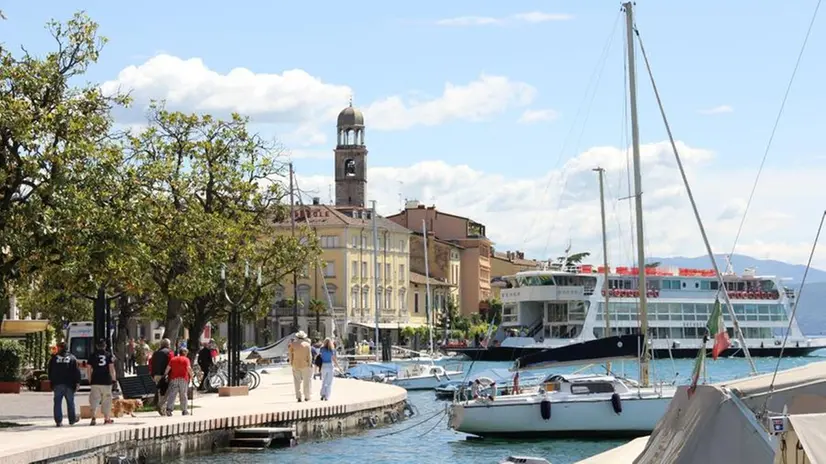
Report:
450,388,675,437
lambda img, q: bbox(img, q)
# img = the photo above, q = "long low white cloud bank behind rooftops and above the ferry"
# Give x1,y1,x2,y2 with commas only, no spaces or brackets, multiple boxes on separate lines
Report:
292,142,826,271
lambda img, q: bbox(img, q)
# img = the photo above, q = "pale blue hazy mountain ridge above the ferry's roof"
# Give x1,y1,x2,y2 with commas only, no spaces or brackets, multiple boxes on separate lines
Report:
648,255,826,284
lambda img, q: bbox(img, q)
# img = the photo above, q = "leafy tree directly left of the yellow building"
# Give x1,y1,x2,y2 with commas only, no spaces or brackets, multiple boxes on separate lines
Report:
129,103,319,346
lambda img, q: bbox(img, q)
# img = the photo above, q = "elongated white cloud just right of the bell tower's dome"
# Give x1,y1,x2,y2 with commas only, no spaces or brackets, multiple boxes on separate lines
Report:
364,74,536,130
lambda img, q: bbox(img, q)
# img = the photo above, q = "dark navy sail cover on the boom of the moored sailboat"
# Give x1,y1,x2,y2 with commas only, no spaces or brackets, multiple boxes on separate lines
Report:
514,334,643,370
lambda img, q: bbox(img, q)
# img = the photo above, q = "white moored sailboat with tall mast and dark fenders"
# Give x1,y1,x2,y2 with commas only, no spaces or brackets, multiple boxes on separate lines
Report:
449,2,677,438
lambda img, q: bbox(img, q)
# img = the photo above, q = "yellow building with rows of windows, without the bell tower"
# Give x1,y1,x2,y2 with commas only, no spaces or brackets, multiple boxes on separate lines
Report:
273,201,410,340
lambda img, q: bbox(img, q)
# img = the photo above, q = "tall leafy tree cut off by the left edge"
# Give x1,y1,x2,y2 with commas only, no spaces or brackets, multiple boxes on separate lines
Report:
0,14,128,315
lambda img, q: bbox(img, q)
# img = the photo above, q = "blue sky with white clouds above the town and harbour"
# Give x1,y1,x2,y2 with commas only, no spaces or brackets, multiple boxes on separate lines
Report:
6,0,826,268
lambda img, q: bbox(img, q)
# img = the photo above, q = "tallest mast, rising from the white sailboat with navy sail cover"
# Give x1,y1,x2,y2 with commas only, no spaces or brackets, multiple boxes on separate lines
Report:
622,2,650,386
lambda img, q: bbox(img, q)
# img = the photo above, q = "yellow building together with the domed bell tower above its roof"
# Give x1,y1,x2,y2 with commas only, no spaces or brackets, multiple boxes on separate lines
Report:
274,103,416,340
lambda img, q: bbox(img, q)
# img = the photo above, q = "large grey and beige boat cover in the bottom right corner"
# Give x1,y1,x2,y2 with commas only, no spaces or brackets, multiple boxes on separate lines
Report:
634,362,826,464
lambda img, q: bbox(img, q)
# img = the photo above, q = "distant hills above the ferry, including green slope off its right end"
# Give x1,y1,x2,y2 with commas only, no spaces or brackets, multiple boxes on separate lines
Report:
648,255,826,335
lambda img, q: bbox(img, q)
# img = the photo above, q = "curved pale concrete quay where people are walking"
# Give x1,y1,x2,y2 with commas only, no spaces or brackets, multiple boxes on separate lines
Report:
0,367,407,464
